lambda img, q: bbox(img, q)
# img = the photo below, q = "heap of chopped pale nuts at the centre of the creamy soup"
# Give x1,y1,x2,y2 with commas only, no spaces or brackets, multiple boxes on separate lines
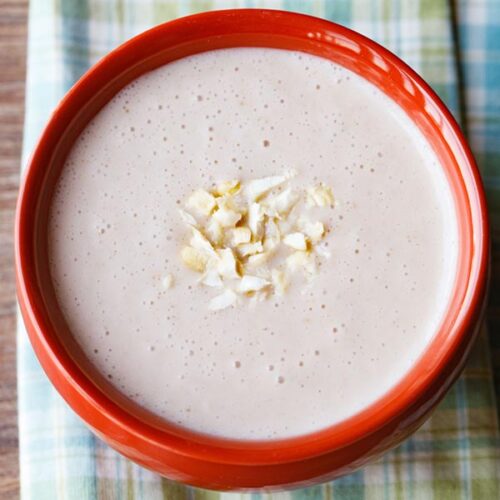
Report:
178,174,334,311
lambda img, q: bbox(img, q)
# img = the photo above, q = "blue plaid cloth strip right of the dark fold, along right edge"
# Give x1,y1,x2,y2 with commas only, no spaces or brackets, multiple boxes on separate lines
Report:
457,0,500,415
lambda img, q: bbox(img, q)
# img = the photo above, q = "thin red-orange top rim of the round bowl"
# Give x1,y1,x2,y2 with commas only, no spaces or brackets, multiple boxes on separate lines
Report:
15,9,489,465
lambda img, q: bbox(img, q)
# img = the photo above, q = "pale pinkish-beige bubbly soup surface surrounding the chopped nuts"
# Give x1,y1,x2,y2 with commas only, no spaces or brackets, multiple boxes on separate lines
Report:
48,48,457,439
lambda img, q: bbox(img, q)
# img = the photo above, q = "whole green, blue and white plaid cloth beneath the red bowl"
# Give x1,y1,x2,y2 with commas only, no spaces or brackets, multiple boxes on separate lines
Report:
18,0,500,500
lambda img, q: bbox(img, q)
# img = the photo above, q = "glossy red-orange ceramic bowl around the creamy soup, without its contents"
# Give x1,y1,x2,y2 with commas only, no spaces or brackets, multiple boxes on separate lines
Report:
16,10,489,490
